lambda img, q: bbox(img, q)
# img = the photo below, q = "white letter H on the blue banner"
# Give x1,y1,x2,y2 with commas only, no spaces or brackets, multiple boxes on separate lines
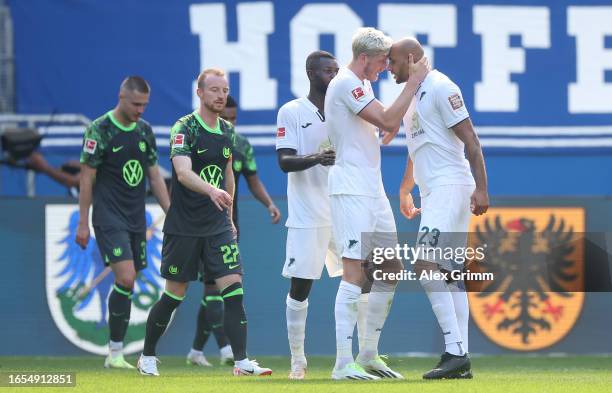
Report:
189,2,277,110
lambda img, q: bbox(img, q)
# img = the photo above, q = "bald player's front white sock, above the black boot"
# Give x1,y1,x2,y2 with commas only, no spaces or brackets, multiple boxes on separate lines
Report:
419,279,464,356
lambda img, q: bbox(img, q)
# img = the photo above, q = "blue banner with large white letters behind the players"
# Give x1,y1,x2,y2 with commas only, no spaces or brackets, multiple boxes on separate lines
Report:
9,0,612,150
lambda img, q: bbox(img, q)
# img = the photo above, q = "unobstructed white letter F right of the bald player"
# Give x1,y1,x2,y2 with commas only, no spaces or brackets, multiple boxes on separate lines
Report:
474,5,550,112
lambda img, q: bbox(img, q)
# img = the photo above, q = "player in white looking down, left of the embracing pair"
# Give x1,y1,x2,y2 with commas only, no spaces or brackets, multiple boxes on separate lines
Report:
276,51,342,379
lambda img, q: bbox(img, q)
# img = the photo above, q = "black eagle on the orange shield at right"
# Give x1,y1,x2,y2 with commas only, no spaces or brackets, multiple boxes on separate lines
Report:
475,215,578,344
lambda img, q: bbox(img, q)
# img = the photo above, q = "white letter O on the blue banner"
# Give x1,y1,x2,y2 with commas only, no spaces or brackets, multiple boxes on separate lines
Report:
289,4,363,97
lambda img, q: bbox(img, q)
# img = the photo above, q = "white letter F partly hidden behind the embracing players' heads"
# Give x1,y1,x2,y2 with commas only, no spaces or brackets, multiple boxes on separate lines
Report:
378,4,457,105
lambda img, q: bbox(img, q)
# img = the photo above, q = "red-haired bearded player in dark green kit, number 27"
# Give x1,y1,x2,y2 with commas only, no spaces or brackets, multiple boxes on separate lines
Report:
138,68,272,376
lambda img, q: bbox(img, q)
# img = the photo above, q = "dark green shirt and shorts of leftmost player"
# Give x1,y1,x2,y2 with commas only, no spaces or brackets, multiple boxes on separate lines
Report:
81,111,157,271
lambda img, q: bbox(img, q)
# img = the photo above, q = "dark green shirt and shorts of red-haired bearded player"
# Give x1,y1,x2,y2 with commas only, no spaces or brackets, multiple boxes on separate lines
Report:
161,112,242,282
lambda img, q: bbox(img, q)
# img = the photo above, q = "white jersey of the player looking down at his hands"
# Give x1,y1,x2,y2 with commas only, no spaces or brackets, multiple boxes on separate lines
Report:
276,97,331,228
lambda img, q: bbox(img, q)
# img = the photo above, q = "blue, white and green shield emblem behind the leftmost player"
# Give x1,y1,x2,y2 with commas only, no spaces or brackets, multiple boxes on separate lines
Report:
45,205,164,355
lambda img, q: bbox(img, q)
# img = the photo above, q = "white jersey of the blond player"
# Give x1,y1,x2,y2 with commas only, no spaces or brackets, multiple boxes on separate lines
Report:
325,67,385,197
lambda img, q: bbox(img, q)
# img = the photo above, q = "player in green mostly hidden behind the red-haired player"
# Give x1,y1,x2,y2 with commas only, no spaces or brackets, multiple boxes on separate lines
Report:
187,96,281,366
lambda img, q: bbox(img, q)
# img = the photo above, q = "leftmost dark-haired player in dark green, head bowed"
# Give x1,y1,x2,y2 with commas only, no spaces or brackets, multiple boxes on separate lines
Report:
76,76,170,369
